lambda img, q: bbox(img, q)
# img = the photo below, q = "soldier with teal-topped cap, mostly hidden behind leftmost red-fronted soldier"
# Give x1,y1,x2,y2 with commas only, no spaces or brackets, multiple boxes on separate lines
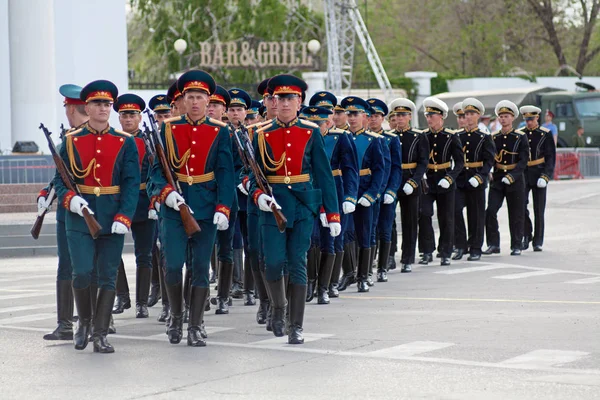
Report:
38,84,88,340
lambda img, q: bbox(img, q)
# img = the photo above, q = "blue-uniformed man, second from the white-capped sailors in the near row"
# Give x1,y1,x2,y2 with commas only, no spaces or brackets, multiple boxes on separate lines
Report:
340,96,385,292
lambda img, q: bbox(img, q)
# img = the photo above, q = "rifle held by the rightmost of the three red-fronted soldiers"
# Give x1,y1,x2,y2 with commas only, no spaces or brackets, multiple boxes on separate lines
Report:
230,125,287,233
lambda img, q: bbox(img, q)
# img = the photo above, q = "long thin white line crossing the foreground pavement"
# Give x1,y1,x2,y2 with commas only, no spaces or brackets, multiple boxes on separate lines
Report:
0,325,600,376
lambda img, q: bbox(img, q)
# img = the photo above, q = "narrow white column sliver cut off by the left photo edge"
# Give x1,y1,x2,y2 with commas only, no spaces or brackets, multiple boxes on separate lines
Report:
0,0,12,153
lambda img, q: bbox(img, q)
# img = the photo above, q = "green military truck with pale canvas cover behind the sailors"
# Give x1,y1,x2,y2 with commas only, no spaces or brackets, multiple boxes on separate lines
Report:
419,84,600,147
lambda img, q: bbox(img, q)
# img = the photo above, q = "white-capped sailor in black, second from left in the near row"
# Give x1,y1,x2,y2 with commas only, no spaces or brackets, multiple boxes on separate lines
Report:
419,97,464,266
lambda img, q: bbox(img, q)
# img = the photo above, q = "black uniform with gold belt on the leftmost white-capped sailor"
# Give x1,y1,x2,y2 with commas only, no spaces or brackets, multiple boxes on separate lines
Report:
394,128,429,272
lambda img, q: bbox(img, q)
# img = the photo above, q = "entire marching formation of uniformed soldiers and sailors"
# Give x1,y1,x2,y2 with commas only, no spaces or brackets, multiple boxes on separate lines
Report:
38,70,556,353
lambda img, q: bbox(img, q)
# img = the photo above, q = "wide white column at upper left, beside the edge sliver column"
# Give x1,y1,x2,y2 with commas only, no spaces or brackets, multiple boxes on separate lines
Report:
8,0,58,153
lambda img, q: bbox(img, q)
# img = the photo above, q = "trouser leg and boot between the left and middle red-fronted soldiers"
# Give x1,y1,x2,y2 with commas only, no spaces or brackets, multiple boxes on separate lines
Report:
131,219,156,318
